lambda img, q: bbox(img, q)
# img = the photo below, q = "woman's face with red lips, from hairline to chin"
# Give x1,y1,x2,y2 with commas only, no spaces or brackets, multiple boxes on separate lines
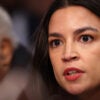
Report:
48,6,100,94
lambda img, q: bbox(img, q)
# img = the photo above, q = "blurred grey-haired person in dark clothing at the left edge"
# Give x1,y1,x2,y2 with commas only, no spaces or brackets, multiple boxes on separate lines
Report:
0,7,31,100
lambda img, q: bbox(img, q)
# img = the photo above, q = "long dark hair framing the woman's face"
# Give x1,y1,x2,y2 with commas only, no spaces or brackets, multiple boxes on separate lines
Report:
33,0,100,99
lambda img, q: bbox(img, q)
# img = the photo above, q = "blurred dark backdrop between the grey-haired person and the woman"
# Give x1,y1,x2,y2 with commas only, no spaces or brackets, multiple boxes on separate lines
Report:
0,0,54,48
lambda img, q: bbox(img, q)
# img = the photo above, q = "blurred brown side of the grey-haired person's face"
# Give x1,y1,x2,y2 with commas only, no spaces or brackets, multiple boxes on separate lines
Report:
0,38,14,79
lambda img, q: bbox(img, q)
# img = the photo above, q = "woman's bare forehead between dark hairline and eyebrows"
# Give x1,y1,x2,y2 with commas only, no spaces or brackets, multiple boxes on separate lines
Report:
49,6,100,30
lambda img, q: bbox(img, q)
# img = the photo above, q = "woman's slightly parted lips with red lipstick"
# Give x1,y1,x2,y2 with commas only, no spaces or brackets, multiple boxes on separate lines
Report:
63,67,84,81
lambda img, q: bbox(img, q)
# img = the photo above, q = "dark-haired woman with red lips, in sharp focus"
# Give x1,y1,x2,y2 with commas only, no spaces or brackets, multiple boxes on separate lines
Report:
33,0,100,100
